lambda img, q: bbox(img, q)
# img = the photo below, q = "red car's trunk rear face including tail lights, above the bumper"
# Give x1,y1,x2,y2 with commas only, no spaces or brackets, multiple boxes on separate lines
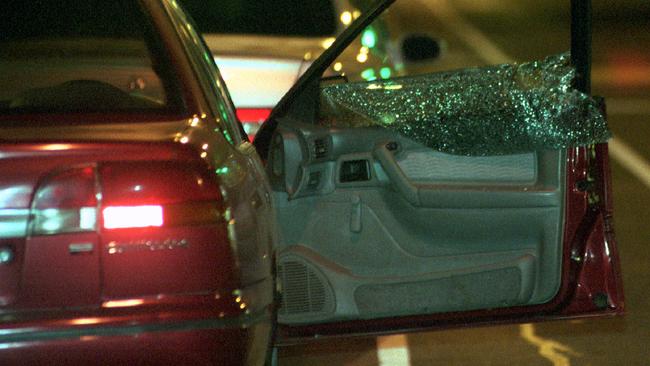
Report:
0,122,233,310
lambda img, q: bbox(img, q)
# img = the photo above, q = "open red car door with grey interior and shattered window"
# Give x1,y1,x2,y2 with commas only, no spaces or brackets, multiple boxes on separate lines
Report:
255,1,623,342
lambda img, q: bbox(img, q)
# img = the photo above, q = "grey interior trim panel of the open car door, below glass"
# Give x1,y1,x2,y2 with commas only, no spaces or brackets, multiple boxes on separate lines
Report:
269,123,566,324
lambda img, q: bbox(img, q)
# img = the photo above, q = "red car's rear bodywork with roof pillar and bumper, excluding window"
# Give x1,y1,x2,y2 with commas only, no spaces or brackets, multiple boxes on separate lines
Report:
0,1,274,365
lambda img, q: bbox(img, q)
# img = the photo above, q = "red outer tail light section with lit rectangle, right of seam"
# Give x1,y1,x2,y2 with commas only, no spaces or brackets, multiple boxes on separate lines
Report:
99,162,222,230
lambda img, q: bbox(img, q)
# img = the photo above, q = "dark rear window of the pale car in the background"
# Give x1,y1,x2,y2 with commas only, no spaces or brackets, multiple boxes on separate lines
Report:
181,0,337,37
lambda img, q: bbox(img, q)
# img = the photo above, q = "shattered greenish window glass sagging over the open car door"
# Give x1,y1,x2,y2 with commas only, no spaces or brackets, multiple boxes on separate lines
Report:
321,54,610,155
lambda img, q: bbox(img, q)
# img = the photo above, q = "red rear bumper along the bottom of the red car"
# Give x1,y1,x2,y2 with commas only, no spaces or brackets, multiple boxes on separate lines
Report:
0,296,271,365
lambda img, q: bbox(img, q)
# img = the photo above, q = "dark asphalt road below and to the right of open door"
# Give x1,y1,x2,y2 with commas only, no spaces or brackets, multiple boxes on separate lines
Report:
280,0,650,366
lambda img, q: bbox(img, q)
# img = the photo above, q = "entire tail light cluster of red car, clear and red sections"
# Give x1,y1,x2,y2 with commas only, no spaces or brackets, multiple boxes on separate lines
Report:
31,162,222,235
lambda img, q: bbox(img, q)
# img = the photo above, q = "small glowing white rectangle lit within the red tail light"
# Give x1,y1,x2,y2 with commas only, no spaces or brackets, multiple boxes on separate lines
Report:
102,205,163,229
